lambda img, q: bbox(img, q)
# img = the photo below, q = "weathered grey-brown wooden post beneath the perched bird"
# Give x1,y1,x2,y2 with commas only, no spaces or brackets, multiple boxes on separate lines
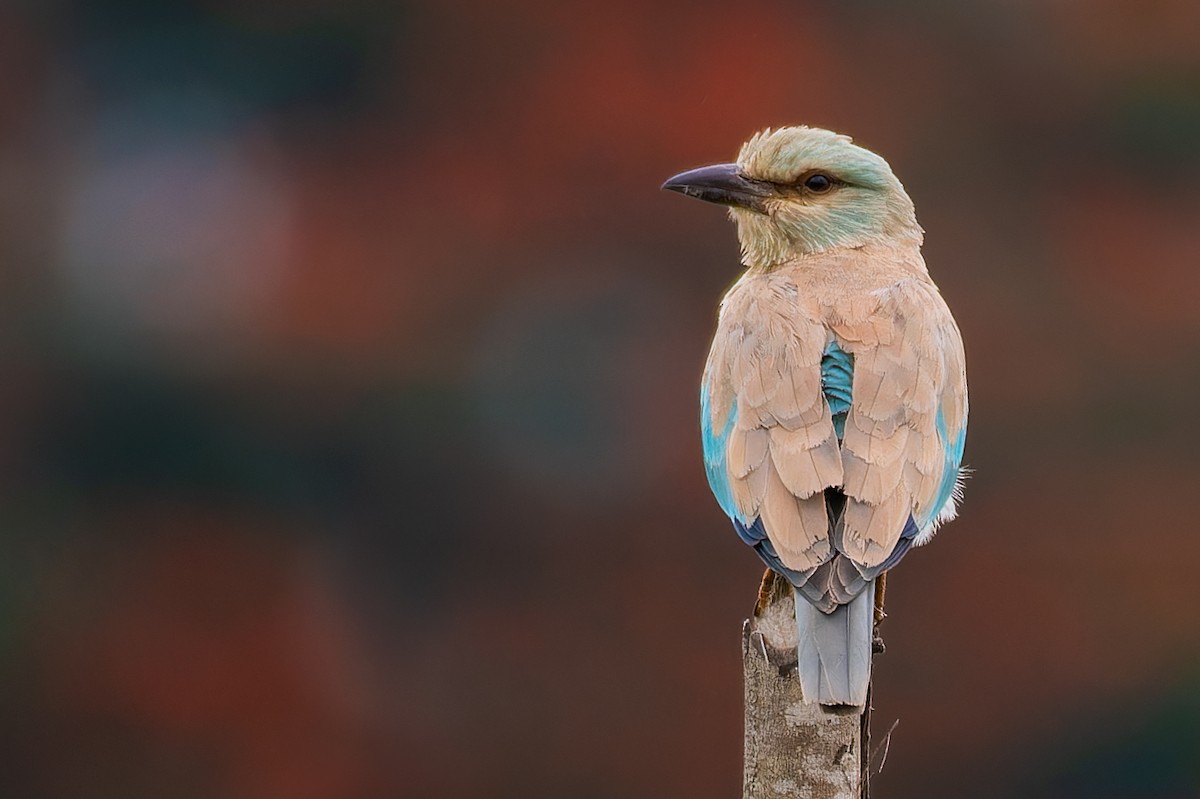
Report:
742,572,870,799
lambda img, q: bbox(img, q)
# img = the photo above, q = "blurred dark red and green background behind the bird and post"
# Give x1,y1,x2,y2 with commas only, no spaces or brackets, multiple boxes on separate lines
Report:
0,0,1200,799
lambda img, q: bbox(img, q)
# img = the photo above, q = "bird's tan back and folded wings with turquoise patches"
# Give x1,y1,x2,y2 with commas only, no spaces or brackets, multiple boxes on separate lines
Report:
702,239,967,611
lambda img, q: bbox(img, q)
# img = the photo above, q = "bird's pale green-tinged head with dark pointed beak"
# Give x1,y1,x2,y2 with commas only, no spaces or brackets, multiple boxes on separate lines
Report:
662,126,922,268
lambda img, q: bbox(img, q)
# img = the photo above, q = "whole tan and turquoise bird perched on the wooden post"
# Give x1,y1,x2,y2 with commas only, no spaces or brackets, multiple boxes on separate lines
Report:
662,127,967,705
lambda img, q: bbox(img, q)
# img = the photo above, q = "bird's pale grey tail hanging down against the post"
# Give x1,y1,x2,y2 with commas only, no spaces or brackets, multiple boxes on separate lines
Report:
796,579,875,705
